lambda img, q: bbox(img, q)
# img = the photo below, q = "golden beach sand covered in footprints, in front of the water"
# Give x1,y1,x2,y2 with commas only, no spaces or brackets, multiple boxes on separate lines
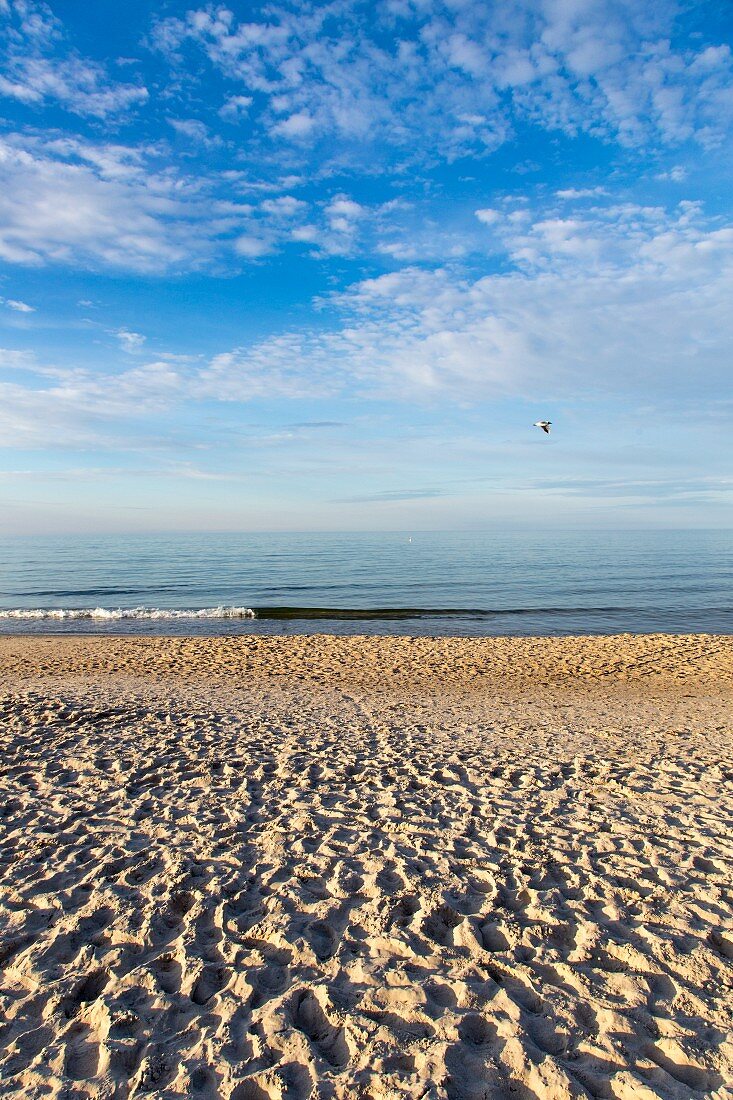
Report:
0,636,733,1100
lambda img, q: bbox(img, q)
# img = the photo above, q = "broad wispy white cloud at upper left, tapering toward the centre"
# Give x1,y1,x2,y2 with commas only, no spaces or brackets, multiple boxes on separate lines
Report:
0,134,411,273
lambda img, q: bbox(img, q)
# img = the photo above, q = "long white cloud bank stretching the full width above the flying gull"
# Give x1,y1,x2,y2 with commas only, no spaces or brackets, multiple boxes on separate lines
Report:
0,204,733,464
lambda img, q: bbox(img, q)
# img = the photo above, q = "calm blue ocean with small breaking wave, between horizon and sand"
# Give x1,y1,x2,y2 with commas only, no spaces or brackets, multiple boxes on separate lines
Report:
0,530,733,636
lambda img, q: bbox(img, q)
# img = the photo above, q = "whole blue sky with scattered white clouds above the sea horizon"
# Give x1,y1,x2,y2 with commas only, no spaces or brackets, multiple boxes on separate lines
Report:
0,0,733,534
